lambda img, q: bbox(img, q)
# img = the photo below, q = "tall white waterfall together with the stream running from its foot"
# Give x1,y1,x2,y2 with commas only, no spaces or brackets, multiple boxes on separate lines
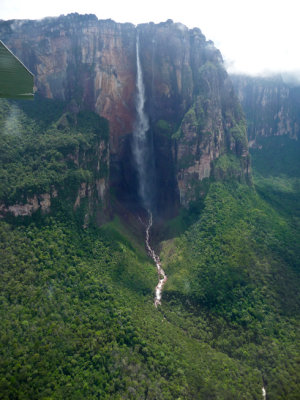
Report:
132,35,167,307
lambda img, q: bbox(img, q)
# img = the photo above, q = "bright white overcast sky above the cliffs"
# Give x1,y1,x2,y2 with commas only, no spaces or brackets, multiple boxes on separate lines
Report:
0,0,300,75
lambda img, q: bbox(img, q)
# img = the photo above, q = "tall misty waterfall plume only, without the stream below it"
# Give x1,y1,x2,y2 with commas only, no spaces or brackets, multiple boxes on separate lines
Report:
133,35,155,211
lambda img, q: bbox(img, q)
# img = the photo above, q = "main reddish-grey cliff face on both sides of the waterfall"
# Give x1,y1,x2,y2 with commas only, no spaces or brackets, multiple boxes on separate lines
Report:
0,14,249,215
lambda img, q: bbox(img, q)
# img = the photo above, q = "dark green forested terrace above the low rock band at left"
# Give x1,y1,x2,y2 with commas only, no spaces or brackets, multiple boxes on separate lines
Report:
0,98,108,204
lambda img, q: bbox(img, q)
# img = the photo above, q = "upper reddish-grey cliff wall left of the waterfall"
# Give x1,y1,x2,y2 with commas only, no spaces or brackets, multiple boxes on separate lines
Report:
0,14,136,152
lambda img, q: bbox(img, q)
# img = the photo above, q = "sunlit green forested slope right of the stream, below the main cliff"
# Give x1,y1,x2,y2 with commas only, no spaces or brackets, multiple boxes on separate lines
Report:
163,183,300,399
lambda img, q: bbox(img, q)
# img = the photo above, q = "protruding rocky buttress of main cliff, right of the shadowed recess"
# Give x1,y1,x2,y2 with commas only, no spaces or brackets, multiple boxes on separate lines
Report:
173,61,250,205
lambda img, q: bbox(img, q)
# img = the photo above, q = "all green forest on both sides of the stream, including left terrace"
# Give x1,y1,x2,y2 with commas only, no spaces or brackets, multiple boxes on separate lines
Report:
0,96,300,400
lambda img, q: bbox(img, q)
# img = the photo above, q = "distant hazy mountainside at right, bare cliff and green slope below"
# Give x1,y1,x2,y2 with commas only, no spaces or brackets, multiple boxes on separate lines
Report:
231,76,300,223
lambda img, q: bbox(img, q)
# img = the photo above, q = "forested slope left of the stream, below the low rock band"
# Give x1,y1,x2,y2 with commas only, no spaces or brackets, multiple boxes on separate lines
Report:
0,211,268,400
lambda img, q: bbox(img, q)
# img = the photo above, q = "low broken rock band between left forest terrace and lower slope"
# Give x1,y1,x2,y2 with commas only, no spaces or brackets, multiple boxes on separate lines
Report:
0,126,109,220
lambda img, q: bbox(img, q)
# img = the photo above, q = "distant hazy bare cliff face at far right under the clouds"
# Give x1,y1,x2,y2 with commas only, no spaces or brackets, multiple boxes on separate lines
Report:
231,75,300,147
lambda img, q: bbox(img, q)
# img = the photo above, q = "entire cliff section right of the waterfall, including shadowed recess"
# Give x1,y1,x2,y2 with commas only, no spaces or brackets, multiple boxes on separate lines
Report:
138,20,249,208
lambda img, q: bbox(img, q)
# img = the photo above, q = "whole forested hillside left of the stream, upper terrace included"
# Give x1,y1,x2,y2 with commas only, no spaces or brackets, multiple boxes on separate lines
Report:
0,98,262,400
